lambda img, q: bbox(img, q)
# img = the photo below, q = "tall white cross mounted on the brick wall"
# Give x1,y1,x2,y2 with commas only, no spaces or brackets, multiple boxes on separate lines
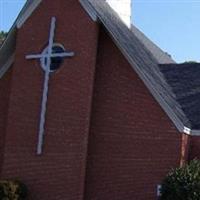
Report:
26,17,74,155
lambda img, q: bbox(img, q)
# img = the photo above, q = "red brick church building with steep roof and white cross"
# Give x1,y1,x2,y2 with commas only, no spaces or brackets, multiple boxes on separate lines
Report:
0,0,200,200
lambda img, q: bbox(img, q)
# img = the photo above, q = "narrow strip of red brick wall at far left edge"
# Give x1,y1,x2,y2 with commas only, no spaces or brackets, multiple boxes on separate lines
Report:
0,70,12,177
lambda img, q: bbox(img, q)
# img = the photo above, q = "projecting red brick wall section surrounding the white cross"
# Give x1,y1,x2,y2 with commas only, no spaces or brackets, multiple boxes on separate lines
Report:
0,0,98,200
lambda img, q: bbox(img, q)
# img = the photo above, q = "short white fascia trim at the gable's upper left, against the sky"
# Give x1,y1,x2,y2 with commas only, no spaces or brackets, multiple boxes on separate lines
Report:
16,0,42,29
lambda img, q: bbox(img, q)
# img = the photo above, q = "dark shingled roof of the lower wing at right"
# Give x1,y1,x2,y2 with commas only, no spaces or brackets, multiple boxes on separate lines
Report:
160,63,200,130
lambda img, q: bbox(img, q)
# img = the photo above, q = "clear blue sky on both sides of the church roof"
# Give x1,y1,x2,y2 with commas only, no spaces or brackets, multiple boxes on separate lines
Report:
0,0,200,62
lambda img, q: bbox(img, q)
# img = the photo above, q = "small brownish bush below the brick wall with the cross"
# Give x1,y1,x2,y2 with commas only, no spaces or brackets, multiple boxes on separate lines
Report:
0,181,28,200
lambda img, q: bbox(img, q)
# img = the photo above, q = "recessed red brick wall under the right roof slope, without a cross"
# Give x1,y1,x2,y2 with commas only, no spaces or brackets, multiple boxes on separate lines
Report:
85,28,181,200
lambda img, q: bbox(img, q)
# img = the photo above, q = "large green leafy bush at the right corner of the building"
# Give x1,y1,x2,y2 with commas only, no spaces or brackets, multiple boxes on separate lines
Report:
160,160,200,200
